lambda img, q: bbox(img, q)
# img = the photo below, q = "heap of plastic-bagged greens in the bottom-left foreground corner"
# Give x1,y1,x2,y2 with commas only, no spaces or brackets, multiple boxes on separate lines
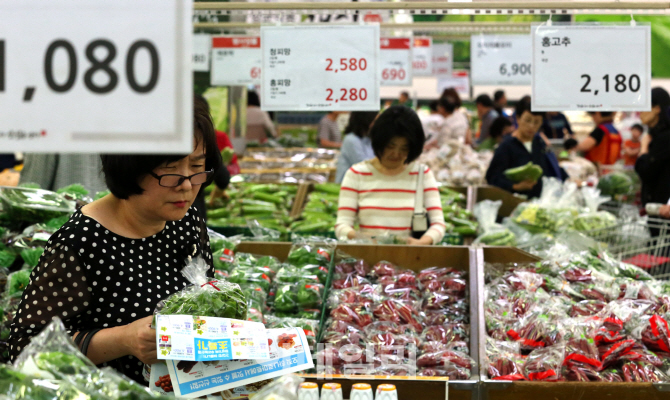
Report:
6,318,169,400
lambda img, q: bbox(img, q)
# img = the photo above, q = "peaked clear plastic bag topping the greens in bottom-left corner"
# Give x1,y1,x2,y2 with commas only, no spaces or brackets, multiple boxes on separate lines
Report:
14,317,97,379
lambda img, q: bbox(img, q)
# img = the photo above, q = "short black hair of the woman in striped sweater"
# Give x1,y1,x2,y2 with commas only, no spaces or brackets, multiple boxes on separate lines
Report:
370,106,426,164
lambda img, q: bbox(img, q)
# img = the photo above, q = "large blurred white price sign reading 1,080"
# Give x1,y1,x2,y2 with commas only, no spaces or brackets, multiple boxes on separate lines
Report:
0,0,193,153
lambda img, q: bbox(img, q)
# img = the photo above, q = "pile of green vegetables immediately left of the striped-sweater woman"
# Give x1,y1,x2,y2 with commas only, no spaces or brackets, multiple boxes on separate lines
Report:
291,183,340,237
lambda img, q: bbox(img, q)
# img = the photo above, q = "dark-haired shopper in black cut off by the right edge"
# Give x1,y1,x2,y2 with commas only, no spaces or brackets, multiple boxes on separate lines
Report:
635,87,670,211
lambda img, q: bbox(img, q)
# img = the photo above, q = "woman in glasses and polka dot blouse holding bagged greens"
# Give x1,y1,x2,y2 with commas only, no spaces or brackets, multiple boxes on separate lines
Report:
10,97,221,382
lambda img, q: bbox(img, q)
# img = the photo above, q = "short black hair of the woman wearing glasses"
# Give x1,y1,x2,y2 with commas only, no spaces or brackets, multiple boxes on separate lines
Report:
100,96,221,200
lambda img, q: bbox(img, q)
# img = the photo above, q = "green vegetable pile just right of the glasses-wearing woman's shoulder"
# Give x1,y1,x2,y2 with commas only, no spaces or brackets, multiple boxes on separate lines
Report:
206,183,298,239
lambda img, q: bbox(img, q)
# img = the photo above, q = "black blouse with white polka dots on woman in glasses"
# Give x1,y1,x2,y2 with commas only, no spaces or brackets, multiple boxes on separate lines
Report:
10,207,213,383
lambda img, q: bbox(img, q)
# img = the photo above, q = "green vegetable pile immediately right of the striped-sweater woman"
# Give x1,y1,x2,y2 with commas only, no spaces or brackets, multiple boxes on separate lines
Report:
440,186,478,244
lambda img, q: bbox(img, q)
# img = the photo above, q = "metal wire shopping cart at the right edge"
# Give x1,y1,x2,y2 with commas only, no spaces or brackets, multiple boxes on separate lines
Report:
583,202,670,280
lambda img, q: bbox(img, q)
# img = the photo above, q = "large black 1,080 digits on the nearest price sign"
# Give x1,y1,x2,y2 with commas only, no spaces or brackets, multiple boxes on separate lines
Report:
0,39,160,102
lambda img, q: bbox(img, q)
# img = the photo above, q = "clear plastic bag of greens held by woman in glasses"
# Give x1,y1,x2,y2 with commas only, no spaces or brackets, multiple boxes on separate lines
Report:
155,258,247,320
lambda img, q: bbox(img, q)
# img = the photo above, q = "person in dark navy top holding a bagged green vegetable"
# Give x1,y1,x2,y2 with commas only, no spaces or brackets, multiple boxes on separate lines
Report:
486,102,568,198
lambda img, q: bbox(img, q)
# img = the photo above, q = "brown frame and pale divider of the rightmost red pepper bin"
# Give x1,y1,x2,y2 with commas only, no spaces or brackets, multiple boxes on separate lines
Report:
473,247,670,400
